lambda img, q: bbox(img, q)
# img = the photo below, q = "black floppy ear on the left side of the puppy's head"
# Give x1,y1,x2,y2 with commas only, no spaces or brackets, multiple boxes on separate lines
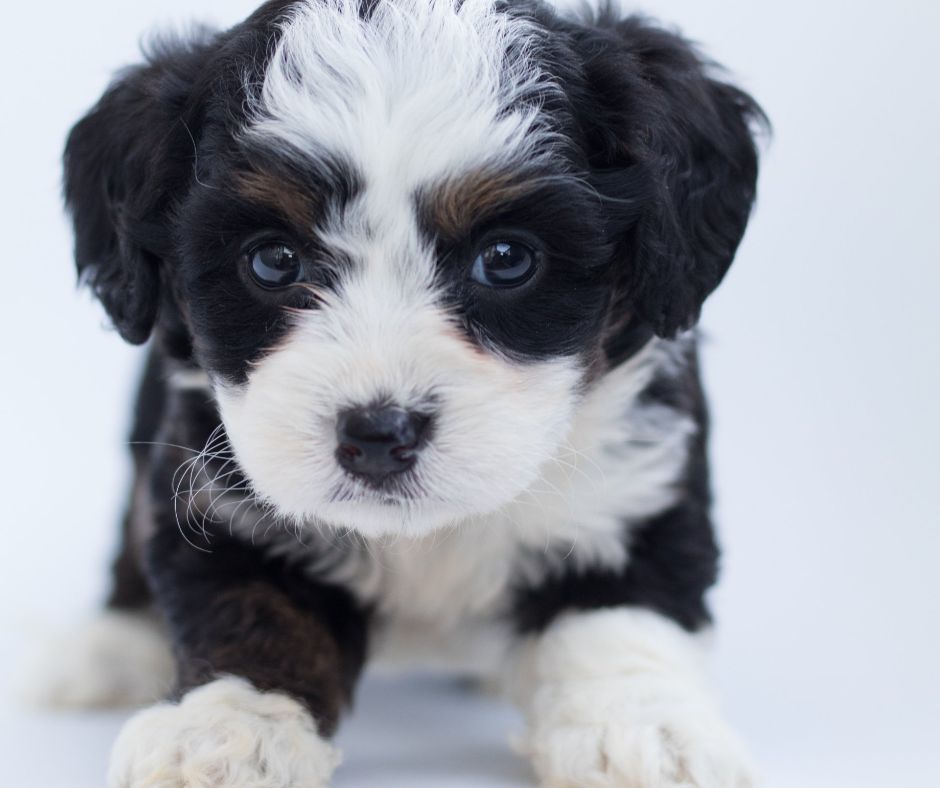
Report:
64,36,209,344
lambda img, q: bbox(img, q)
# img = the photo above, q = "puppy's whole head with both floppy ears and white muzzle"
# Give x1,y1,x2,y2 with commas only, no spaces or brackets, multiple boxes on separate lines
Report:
66,0,758,534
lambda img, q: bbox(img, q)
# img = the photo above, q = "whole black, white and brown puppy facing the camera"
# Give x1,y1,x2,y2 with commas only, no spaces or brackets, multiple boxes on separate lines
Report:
49,0,762,788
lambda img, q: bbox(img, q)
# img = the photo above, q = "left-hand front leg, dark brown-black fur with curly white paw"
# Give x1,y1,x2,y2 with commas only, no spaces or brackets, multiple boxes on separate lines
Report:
109,527,367,788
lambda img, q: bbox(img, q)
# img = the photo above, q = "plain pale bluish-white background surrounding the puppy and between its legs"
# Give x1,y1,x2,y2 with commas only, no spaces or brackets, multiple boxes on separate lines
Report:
0,0,940,788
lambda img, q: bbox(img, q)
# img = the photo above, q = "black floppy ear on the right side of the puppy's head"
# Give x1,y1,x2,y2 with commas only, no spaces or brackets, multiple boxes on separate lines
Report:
560,12,766,337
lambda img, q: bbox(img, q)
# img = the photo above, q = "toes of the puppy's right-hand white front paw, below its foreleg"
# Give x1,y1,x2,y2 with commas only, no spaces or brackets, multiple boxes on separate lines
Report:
523,679,756,788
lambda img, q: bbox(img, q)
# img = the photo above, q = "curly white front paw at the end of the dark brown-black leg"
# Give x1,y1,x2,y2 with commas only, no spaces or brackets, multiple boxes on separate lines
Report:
108,678,340,788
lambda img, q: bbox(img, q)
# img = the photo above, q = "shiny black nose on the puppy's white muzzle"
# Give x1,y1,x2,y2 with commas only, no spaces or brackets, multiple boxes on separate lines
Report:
336,406,431,481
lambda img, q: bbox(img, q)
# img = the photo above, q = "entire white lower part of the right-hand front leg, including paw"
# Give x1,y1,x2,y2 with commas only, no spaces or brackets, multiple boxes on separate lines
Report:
509,608,755,788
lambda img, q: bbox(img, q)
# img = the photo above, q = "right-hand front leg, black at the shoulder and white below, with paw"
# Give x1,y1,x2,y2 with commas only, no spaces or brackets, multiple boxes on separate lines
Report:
513,456,755,788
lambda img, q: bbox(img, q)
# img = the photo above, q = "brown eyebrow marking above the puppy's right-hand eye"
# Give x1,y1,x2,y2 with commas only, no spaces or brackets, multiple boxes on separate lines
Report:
420,170,539,238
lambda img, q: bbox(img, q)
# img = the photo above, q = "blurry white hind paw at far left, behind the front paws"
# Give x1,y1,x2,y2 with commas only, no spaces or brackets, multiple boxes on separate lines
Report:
24,611,175,708
